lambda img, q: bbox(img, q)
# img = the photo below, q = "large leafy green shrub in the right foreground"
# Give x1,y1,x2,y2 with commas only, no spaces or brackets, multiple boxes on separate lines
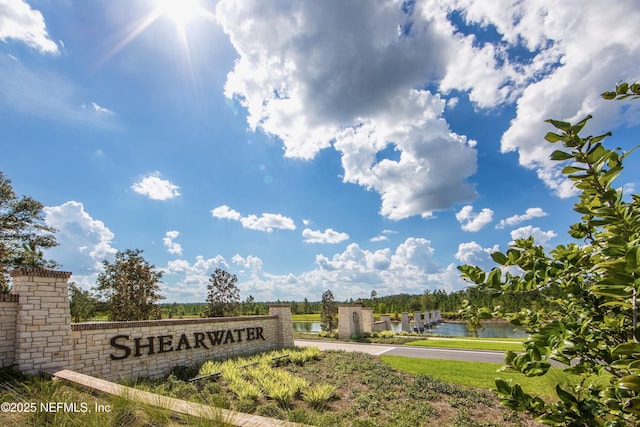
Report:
459,83,640,427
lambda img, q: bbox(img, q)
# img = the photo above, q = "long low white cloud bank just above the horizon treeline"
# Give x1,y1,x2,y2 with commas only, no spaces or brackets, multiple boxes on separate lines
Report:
164,238,468,301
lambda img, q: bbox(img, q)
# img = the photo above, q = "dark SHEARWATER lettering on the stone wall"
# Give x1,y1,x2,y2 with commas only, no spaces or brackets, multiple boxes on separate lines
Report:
110,326,266,360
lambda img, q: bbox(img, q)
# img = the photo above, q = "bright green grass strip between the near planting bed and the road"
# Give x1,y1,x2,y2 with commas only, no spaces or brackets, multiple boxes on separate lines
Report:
381,355,580,399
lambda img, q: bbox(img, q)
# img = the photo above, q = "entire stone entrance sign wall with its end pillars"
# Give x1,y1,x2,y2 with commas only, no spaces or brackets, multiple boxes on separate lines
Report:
0,269,294,380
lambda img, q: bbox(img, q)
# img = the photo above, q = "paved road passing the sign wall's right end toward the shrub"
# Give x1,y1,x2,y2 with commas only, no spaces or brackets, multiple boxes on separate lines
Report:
295,340,504,364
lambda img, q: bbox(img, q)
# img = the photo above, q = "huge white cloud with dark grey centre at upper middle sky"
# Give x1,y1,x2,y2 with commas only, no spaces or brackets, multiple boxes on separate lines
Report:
216,1,476,219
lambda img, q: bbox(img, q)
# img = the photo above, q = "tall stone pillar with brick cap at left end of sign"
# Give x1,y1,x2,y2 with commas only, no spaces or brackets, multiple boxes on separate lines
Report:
11,268,73,374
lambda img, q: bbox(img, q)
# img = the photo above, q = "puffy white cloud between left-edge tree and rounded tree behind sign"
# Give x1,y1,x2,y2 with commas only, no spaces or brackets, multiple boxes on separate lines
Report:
43,201,117,277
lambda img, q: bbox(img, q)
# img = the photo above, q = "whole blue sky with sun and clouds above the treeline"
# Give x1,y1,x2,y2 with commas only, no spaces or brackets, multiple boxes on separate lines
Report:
0,0,640,302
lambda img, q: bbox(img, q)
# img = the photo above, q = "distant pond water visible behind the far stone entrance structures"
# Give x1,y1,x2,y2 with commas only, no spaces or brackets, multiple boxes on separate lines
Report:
293,322,527,338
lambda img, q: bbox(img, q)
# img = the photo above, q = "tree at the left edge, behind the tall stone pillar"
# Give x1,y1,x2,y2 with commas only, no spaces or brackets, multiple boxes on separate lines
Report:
0,172,58,293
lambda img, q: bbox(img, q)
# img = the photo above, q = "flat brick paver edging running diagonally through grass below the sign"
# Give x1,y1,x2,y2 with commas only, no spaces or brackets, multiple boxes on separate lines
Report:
53,369,310,427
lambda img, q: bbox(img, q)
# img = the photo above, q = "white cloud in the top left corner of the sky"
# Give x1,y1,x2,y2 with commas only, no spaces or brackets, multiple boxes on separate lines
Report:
0,0,58,53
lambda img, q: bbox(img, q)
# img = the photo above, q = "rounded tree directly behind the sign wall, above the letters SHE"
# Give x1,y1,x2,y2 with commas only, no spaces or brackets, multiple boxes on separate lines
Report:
95,249,164,321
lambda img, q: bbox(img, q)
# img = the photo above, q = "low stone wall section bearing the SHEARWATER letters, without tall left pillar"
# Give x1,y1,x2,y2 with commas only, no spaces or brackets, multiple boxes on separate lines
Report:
70,316,293,381
